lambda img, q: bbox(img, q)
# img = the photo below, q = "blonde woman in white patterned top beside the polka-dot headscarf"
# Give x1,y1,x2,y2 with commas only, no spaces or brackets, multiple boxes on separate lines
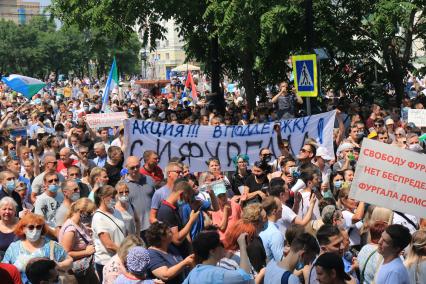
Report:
102,235,145,284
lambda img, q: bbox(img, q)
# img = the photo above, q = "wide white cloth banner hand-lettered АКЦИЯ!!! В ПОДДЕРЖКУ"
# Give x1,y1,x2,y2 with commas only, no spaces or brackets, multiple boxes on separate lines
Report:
124,111,336,172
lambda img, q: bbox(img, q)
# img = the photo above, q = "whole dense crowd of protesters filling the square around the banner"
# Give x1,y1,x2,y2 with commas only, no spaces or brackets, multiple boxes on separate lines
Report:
0,72,426,284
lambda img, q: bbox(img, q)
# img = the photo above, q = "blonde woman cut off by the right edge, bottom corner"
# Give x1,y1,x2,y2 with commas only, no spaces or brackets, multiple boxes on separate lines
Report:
404,230,426,284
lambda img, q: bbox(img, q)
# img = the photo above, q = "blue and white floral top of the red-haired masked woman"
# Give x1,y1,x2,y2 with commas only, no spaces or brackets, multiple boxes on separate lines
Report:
2,239,67,284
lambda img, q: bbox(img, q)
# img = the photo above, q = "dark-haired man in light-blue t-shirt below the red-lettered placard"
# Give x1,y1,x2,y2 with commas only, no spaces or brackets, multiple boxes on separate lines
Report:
375,224,411,284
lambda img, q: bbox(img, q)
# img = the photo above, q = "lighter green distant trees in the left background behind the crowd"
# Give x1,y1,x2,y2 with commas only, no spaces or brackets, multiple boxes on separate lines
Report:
0,16,141,78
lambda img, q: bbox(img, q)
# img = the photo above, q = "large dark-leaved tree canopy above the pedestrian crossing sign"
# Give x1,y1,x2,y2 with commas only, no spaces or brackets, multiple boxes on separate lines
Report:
48,0,426,106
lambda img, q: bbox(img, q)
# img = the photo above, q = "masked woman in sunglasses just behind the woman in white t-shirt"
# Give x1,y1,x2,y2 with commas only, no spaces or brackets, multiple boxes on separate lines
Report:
115,181,141,234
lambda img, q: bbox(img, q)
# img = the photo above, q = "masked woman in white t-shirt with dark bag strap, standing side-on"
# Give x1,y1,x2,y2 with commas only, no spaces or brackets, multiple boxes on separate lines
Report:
92,185,127,283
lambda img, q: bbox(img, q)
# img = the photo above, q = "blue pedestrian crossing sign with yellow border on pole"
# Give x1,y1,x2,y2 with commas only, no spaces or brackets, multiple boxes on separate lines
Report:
291,54,318,97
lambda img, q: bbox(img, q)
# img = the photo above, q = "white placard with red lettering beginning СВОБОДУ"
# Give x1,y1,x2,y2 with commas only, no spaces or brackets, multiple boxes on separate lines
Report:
349,139,426,217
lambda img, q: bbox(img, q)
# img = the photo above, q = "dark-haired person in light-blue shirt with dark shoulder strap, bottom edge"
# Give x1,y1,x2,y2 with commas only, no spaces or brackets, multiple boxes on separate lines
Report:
264,233,320,284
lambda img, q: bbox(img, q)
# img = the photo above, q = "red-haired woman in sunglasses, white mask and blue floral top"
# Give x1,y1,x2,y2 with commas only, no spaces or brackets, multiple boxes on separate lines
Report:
3,213,72,283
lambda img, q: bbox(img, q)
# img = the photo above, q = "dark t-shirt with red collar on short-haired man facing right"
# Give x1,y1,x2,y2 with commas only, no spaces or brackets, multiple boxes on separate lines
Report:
157,200,192,258
